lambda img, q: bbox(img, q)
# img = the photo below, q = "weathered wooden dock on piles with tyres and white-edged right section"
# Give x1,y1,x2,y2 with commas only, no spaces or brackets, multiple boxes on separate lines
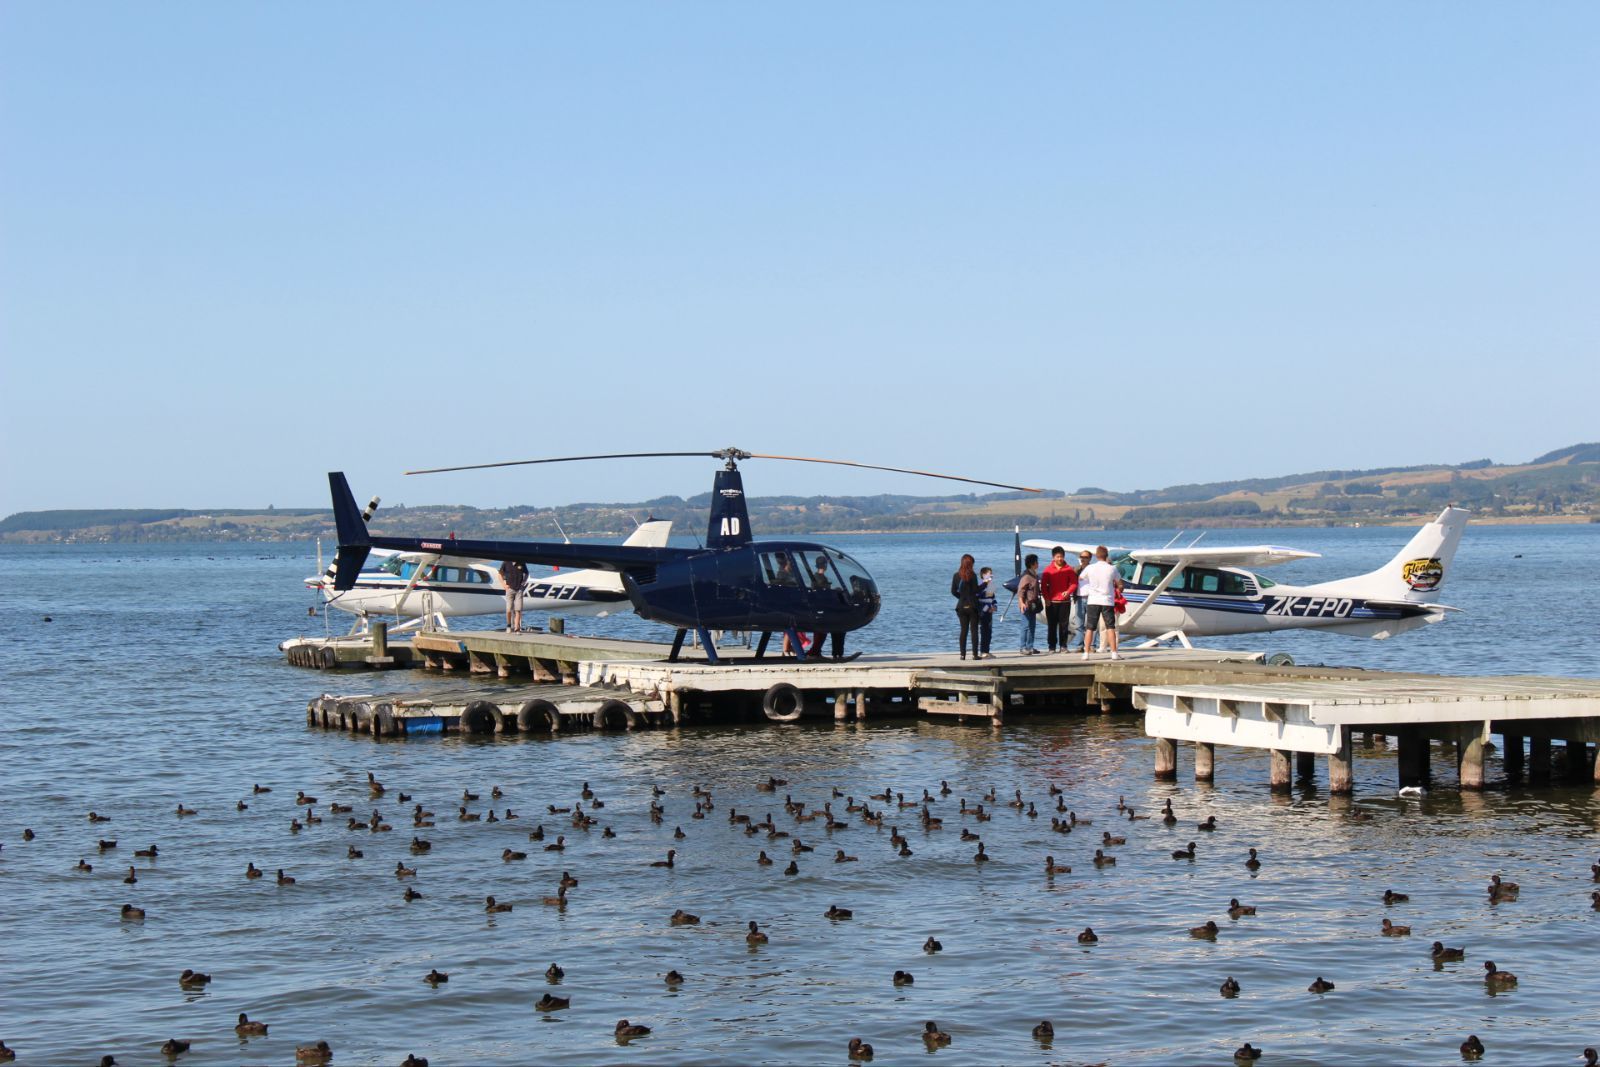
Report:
291,630,1600,795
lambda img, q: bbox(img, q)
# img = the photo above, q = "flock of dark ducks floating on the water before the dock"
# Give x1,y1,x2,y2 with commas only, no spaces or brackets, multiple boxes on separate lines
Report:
0,773,1600,1067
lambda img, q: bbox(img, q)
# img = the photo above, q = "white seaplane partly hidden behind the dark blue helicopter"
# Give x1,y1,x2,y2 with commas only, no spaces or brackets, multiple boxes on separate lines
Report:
306,498,672,633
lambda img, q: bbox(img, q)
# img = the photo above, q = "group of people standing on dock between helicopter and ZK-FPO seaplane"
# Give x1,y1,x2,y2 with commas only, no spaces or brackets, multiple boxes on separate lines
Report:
950,545,1126,659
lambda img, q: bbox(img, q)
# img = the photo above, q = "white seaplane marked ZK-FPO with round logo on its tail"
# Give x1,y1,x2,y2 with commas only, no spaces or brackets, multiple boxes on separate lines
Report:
1022,507,1467,646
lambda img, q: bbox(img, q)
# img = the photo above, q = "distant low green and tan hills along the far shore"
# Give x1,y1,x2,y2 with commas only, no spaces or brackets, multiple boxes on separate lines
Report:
0,443,1600,542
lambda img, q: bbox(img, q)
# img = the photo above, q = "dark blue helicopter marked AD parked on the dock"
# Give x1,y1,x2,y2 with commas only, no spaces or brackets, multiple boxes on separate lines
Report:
328,448,1040,664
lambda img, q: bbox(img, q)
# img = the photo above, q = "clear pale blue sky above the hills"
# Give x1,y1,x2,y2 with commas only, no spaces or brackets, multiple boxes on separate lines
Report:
0,0,1600,514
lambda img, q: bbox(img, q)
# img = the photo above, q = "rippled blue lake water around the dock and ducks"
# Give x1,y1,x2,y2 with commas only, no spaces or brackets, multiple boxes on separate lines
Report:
0,526,1600,1064
